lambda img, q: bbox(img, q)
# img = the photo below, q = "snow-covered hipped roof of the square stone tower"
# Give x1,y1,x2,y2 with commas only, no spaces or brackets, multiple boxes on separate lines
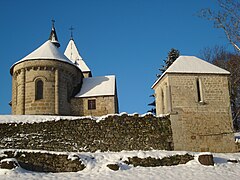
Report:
152,56,230,88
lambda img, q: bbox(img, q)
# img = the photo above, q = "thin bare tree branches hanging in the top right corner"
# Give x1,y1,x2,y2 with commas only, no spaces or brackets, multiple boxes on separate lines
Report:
198,0,240,52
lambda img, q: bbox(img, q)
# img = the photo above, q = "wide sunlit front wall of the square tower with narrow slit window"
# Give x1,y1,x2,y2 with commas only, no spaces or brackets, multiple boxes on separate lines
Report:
168,74,236,152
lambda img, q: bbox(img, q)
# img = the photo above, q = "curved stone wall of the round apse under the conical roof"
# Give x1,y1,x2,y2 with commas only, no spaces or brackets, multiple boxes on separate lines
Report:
12,60,83,115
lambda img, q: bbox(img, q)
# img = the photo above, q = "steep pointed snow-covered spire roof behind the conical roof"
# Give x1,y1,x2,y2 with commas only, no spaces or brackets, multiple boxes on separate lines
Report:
64,39,90,72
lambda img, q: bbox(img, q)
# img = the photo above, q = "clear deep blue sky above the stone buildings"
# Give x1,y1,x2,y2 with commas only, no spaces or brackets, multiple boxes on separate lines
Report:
0,0,230,114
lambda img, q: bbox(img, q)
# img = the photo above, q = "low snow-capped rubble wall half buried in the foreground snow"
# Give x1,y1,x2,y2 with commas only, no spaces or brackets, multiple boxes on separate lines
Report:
0,150,195,172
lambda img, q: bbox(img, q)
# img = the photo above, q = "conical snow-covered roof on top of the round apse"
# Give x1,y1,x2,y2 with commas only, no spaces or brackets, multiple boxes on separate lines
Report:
11,40,73,69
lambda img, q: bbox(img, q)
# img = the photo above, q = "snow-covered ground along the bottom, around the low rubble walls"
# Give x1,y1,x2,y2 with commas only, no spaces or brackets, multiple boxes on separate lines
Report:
0,151,240,180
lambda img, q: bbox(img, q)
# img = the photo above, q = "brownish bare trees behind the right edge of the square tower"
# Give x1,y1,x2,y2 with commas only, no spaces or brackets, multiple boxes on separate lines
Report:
201,46,240,130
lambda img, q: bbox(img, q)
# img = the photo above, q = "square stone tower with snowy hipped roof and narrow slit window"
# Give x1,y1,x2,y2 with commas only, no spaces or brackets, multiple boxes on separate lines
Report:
152,56,235,152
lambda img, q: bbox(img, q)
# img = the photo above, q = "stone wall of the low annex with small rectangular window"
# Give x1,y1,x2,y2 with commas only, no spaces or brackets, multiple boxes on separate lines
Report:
71,96,118,116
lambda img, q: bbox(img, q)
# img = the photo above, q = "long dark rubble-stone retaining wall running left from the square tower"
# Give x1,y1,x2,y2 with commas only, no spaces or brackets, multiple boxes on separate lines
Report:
0,114,173,152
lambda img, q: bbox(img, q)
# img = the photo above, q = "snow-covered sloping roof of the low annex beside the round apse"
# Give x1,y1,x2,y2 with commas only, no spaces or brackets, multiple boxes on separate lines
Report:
75,75,116,97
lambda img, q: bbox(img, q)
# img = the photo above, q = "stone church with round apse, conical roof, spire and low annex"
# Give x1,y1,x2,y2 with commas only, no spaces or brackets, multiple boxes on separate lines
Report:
10,22,118,116
